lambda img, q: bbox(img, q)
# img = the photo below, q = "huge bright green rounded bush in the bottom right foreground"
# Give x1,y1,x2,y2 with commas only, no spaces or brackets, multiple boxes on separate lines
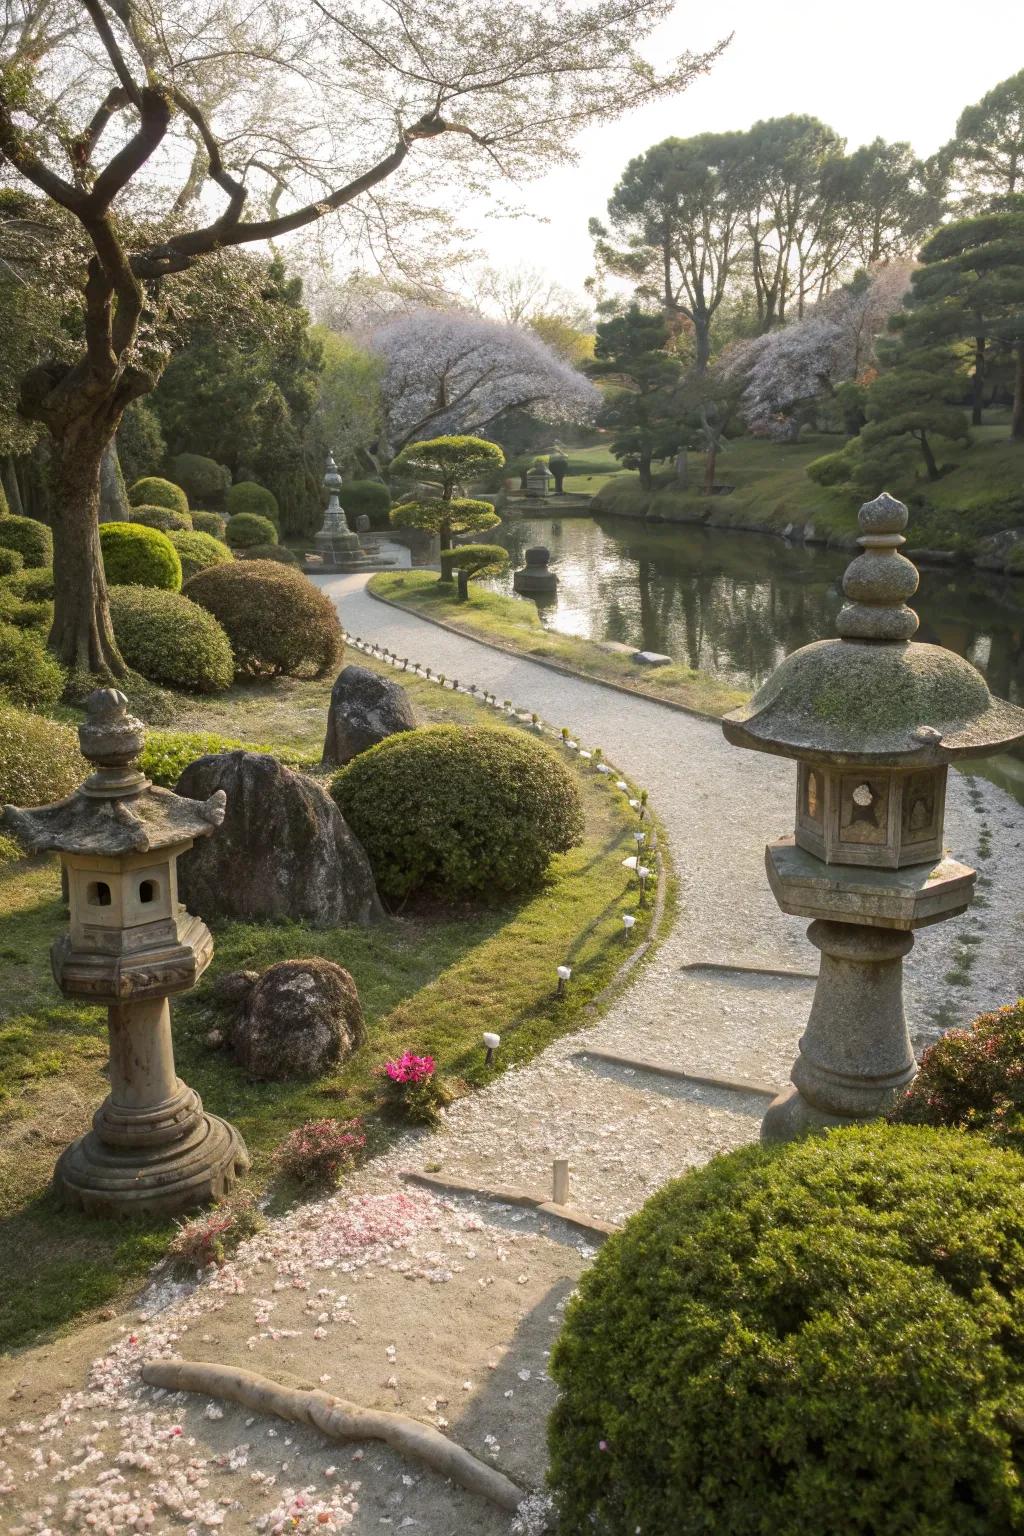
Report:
550,1124,1024,1536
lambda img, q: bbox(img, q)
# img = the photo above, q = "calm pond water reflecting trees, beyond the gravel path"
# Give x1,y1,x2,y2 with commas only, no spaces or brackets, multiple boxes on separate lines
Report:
490,518,1024,800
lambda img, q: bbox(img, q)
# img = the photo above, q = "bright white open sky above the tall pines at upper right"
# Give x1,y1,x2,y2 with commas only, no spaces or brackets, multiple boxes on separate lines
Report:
474,0,1024,290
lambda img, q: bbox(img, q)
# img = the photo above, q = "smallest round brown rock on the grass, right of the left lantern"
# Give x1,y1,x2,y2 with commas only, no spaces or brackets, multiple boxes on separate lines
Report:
230,958,365,1078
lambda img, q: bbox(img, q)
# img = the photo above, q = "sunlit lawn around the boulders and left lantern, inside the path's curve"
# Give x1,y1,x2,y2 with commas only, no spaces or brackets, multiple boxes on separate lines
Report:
0,662,666,1347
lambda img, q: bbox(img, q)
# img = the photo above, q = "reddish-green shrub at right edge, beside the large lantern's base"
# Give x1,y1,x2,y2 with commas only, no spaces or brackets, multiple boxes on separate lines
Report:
892,998,1024,1152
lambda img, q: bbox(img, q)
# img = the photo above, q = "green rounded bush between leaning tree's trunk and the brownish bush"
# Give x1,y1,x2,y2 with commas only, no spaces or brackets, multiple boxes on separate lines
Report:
111,587,235,693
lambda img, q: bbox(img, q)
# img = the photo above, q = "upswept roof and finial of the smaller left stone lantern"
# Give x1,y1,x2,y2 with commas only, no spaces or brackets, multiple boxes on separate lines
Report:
0,688,226,859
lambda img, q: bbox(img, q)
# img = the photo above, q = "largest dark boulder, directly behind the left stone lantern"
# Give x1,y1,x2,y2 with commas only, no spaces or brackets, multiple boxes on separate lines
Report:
178,751,381,928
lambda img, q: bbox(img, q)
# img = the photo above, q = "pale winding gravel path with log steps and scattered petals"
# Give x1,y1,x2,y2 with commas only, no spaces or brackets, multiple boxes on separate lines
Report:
0,576,1024,1536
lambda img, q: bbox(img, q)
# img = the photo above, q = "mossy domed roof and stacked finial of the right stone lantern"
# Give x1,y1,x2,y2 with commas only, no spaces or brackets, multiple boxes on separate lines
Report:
722,492,1024,766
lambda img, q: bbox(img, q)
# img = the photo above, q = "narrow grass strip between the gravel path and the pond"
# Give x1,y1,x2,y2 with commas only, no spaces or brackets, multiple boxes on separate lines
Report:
370,570,746,725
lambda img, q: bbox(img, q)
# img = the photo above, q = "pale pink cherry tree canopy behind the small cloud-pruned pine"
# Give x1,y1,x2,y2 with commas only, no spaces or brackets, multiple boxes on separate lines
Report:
372,309,600,449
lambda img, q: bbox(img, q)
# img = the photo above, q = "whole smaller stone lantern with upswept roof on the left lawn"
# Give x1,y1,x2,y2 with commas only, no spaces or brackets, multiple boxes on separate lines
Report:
0,688,249,1215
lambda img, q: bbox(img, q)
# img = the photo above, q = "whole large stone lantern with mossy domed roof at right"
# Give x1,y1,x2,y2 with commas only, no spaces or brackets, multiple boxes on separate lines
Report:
722,493,1024,1141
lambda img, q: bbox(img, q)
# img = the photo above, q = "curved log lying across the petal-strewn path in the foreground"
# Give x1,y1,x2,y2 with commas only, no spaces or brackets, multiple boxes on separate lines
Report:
143,1359,527,1513
